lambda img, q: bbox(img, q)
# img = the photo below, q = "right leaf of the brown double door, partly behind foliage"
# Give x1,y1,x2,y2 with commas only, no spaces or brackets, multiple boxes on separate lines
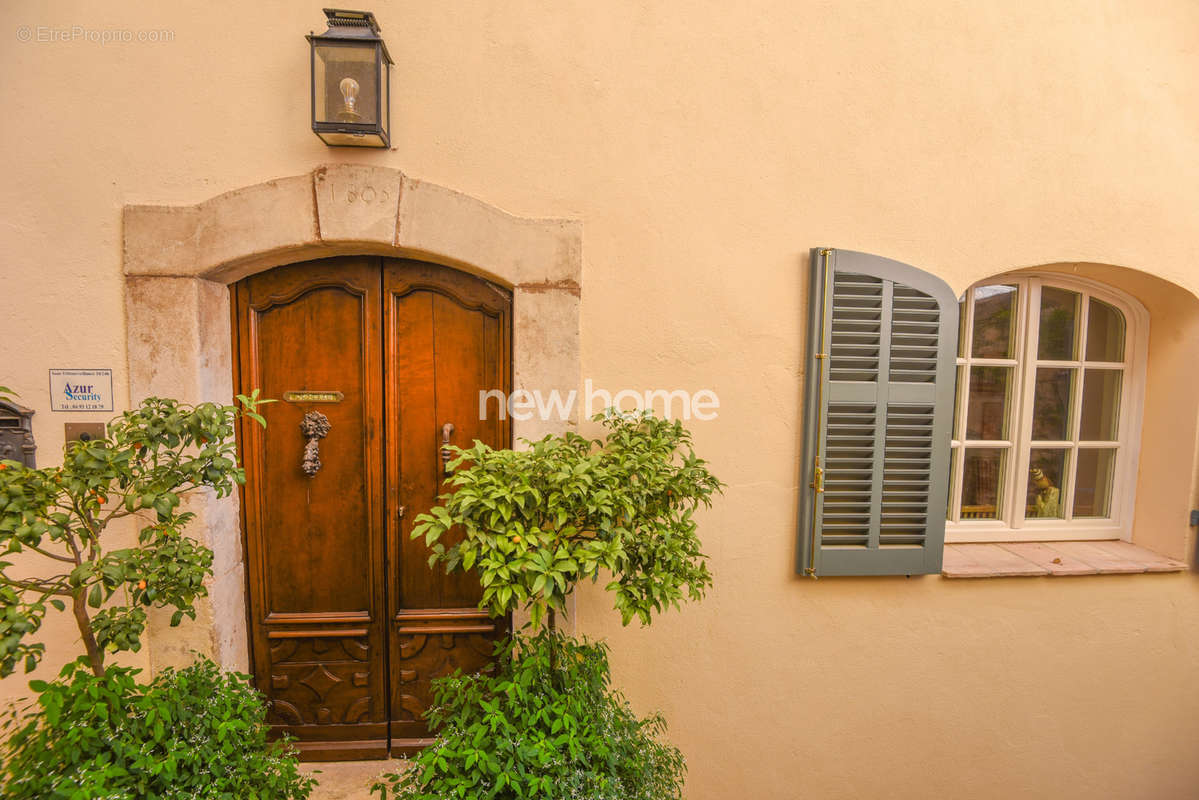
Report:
384,259,511,754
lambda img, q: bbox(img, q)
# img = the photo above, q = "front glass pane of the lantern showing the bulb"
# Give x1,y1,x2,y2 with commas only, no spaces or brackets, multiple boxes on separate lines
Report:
312,42,376,127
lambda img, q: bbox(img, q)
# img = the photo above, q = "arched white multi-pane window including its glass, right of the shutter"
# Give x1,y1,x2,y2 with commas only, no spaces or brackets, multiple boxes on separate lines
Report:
946,275,1149,542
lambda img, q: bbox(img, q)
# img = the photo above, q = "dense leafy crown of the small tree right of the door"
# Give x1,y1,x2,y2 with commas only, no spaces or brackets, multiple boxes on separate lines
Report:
412,410,722,625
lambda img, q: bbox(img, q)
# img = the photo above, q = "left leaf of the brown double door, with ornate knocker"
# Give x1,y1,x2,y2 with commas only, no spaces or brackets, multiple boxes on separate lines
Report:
235,258,387,759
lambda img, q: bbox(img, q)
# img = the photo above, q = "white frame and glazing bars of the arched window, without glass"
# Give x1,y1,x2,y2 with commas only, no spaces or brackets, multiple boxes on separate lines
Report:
945,272,1149,543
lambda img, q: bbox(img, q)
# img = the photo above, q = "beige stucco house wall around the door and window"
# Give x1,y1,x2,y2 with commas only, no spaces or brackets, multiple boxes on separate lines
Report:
0,0,1199,800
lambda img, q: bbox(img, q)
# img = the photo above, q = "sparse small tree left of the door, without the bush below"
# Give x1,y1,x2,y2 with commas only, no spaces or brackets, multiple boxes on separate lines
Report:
0,390,270,676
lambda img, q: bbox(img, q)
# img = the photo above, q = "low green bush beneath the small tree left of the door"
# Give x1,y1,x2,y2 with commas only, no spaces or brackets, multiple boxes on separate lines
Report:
0,658,313,800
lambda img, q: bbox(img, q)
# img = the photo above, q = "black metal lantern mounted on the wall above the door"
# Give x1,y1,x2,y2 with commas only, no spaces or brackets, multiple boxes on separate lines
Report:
307,8,393,148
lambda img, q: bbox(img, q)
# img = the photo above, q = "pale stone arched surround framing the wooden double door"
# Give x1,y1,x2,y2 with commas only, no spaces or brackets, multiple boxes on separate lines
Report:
123,164,583,672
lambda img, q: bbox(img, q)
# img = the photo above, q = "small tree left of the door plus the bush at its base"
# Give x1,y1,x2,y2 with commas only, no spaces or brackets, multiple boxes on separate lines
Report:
0,387,315,800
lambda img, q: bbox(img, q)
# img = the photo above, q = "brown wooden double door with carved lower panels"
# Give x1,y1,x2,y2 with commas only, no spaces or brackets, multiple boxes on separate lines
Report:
233,257,512,760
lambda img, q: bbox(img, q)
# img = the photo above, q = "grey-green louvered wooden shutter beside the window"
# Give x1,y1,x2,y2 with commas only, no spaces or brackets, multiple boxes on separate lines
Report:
799,249,958,576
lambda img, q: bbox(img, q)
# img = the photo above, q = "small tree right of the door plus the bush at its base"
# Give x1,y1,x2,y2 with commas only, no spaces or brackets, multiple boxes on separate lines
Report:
373,411,722,800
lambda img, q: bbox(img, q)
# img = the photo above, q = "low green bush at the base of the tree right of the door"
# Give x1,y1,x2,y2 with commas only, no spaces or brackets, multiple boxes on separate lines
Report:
374,630,686,800
